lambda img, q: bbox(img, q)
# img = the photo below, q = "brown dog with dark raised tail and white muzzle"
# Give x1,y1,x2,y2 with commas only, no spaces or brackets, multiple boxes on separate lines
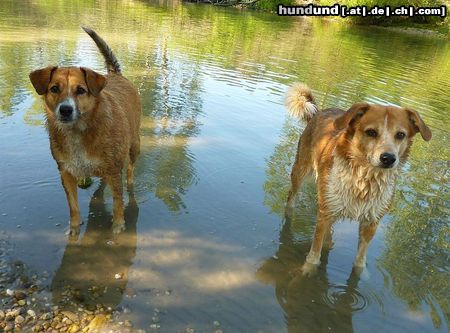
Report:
30,27,141,235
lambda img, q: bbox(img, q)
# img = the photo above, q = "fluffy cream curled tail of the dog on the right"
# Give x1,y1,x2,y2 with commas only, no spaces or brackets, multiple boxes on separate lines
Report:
284,83,317,122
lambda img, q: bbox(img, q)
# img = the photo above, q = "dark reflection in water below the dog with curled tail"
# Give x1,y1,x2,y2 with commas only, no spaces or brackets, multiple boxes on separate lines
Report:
256,214,367,333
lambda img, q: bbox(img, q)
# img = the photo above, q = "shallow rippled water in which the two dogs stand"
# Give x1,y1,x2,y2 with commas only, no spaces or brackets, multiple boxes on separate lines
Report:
0,0,450,332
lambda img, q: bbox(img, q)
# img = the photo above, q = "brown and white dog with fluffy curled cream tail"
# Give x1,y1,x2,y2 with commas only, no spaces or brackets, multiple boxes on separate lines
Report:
286,84,431,272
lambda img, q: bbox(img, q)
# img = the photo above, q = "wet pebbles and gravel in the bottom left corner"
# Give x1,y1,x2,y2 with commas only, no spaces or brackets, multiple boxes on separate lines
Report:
0,239,142,333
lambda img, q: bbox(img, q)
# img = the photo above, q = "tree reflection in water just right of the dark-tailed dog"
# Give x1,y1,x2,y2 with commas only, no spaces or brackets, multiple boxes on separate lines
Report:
136,39,202,211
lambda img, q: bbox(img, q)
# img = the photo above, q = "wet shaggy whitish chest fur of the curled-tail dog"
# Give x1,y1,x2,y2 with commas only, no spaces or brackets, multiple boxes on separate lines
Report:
325,157,398,222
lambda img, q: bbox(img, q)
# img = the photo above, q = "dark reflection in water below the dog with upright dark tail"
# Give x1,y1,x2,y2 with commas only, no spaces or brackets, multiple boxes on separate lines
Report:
51,182,139,307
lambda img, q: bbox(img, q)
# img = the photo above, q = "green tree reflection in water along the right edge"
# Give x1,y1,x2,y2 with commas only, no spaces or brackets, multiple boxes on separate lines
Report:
381,133,450,328
